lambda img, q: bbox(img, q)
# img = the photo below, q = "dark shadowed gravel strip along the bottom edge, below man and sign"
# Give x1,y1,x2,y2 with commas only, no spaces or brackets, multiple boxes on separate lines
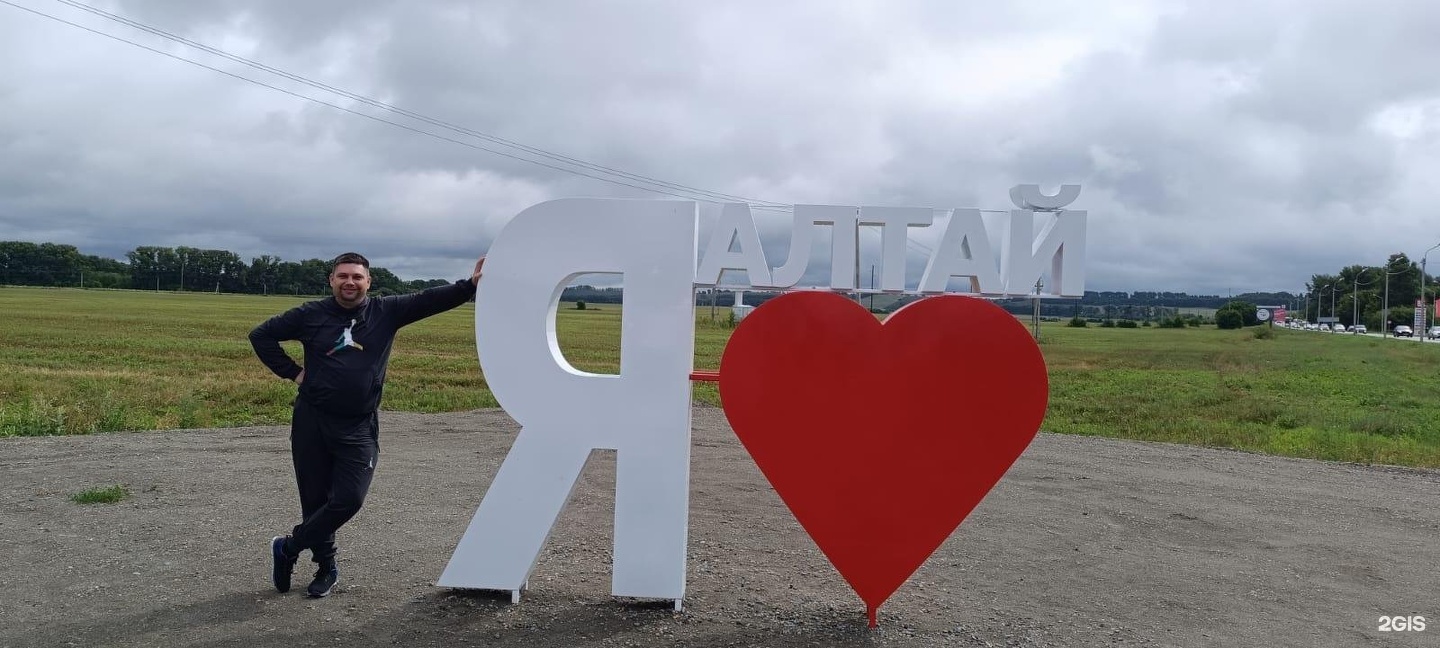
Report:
22,589,950,648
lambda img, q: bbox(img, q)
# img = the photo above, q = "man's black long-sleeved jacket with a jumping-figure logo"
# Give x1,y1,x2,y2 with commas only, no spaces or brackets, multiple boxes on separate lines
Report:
251,279,475,416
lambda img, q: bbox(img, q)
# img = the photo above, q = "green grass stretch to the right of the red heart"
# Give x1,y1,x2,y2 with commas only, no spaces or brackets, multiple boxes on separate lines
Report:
1041,325,1440,468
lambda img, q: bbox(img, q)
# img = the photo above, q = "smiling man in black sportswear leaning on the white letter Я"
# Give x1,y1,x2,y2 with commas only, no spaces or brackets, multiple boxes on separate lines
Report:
251,252,485,598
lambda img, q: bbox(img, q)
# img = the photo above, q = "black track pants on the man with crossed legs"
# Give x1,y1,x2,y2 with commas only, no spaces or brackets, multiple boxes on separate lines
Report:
287,399,380,563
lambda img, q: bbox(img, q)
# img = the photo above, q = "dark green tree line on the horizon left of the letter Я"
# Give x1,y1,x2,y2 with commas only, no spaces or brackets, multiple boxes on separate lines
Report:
0,240,449,295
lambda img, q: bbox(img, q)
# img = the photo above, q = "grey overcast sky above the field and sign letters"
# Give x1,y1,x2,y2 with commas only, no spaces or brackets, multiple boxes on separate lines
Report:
0,0,1440,295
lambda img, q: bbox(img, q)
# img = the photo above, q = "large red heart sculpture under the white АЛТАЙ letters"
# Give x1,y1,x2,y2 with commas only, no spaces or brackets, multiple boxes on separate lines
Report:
720,292,1050,626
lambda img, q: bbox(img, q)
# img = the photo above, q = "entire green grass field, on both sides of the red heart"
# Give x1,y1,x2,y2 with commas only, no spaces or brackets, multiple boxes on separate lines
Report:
0,288,1440,467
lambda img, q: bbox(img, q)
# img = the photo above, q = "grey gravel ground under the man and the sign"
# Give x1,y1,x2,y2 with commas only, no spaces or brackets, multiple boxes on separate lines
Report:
0,408,1440,647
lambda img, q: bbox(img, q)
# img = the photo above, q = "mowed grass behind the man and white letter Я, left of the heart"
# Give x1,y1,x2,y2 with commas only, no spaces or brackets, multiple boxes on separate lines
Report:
0,288,730,436
